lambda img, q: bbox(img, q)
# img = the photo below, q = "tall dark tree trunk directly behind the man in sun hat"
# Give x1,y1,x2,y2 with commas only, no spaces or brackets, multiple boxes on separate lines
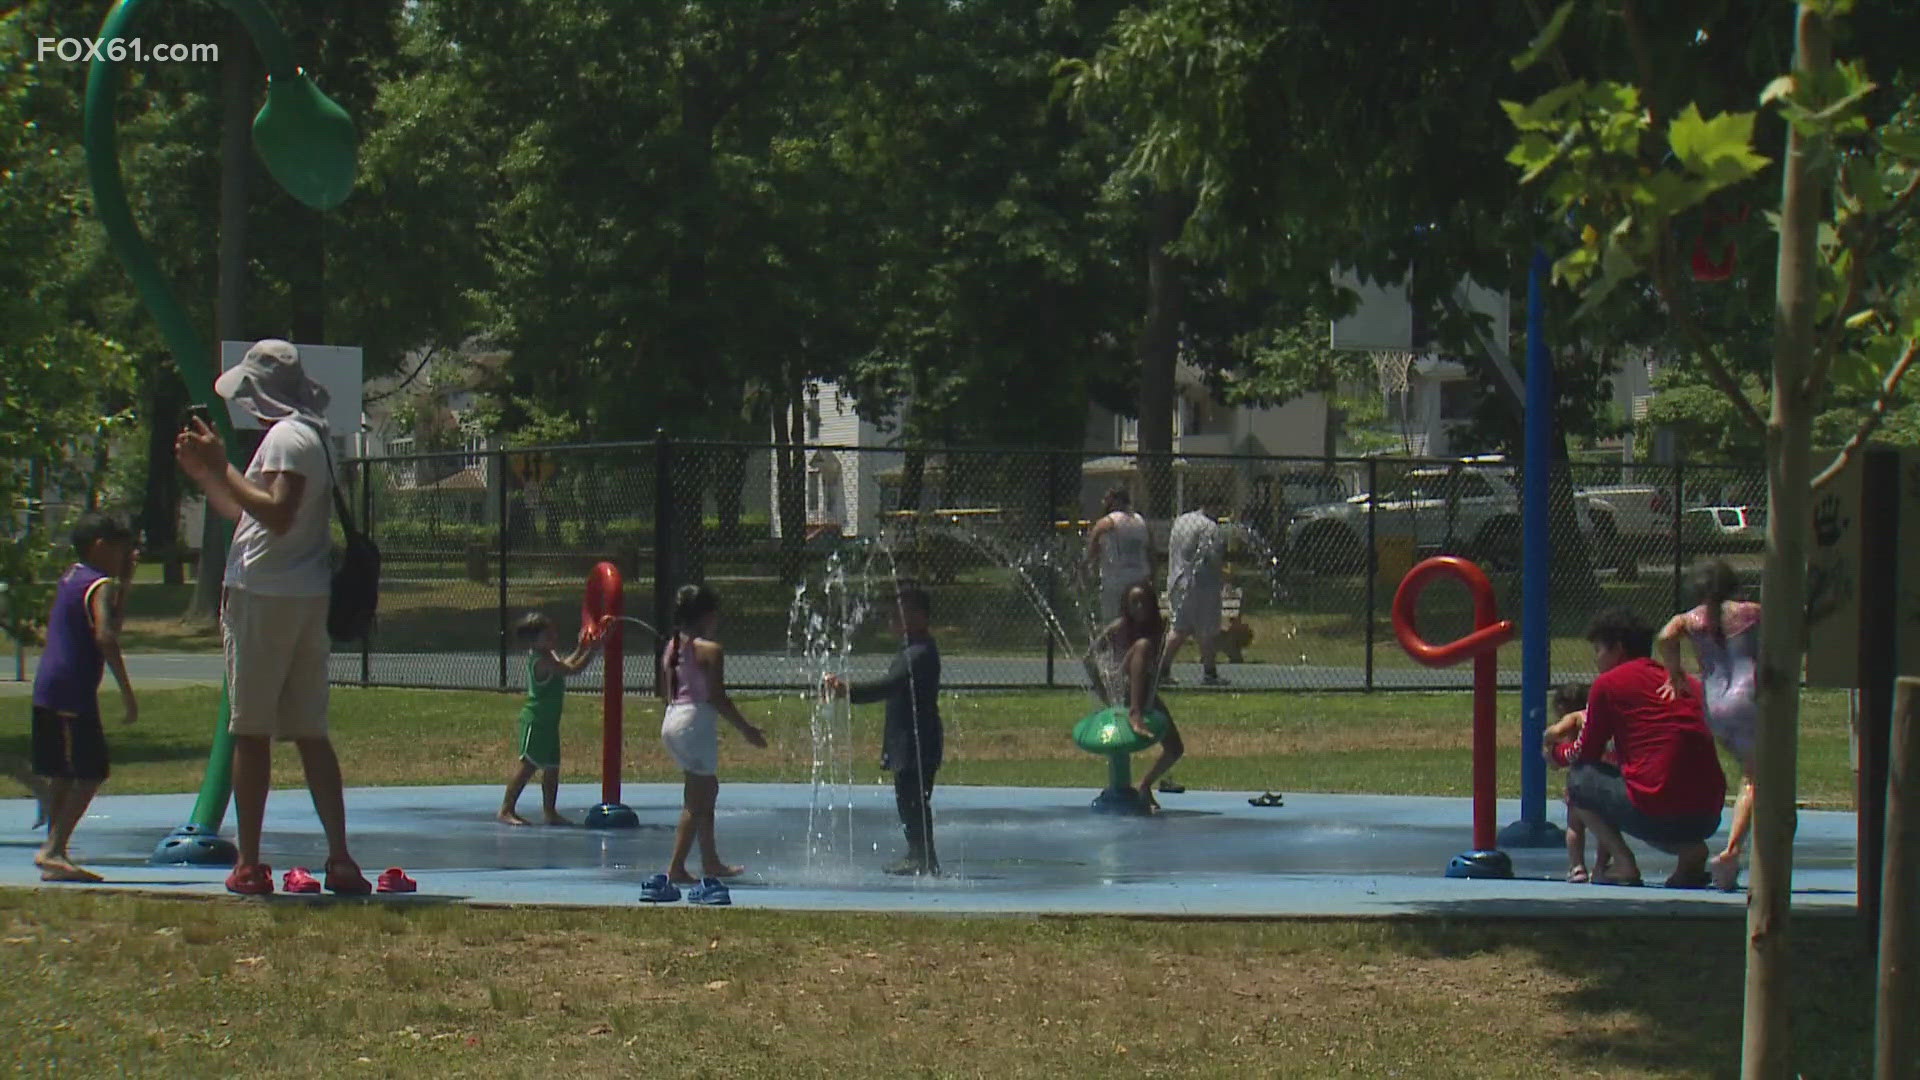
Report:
189,29,255,623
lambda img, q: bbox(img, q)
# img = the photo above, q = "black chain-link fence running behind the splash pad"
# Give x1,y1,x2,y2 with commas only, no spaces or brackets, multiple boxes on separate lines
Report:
332,438,1766,692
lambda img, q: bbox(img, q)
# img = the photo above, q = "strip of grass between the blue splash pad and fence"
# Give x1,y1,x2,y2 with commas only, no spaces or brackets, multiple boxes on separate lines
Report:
0,688,1853,809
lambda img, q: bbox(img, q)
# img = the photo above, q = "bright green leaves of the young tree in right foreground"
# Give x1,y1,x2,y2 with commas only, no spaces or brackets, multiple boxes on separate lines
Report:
1503,6,1920,454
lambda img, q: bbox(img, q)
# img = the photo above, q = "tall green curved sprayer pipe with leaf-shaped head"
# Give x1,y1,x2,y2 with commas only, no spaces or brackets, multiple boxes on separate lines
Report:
84,0,355,832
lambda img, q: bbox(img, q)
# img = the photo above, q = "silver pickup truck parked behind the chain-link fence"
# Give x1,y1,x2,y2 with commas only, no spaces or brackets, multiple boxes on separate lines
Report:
1286,465,1630,573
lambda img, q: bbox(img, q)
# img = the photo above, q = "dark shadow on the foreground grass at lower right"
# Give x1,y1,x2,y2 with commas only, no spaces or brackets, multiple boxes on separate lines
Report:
1394,903,1876,1076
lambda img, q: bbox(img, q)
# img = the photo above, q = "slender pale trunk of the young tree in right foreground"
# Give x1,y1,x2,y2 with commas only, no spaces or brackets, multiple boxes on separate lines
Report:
1741,6,1832,1080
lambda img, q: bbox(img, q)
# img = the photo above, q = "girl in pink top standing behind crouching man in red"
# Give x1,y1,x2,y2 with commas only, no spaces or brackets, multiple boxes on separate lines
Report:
1659,559,1761,890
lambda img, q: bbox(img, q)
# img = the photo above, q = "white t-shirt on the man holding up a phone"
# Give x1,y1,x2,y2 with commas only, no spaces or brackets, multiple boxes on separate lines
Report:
227,421,334,596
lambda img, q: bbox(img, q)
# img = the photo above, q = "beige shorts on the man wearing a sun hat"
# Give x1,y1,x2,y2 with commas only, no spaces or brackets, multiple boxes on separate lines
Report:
221,588,332,740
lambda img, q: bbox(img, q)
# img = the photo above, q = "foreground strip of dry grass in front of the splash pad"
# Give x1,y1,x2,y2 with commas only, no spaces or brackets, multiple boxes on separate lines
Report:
0,890,1874,1080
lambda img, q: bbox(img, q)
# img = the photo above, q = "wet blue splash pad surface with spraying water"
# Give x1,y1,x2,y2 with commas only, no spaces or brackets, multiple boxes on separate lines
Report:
22,526,1855,919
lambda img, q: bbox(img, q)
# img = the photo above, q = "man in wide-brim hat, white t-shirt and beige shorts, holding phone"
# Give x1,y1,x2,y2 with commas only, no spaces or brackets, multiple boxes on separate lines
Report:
173,338,372,896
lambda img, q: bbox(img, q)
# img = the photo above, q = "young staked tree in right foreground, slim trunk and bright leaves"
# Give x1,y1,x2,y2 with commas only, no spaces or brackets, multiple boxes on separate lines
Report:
1507,0,1920,1078
